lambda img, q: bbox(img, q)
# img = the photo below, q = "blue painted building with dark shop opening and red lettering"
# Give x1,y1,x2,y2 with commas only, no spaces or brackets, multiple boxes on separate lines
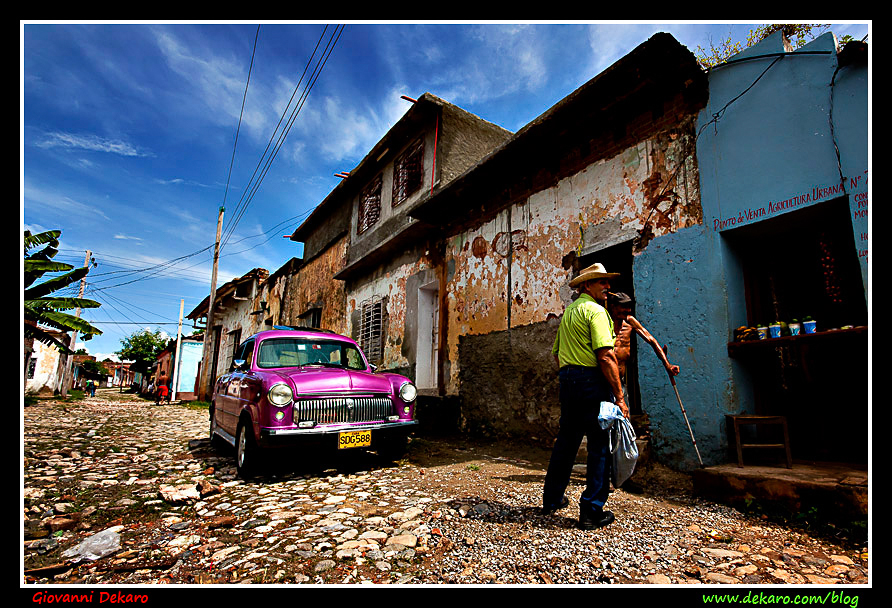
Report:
633,33,870,468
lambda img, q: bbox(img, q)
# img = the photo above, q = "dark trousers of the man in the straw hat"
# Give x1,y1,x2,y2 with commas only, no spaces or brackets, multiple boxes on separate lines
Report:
542,366,613,511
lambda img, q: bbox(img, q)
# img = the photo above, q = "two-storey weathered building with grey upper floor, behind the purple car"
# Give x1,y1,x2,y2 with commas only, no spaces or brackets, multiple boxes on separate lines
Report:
292,93,511,393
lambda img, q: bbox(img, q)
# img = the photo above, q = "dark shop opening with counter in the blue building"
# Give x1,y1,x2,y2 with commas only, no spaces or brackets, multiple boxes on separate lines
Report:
723,198,869,464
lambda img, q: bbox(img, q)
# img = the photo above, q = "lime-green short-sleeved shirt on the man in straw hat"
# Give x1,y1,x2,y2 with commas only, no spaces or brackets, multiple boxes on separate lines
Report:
551,293,615,367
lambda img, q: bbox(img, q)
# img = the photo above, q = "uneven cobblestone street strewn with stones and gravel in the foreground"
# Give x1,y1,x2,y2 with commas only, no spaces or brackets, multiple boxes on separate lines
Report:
23,389,868,591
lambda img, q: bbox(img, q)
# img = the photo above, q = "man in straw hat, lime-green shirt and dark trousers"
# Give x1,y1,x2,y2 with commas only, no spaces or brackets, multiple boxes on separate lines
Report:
542,264,629,530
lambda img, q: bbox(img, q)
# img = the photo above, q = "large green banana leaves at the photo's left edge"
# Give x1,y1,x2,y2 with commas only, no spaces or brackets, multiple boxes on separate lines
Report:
24,230,102,355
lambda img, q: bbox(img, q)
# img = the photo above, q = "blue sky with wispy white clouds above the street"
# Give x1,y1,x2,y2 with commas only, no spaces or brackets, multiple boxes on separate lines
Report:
20,22,869,359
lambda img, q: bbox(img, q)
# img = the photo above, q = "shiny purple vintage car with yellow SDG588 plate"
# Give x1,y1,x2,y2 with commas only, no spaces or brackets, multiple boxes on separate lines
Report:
210,327,417,477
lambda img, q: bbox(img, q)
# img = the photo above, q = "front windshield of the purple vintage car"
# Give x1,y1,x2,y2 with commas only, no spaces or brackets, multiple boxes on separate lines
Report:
257,338,366,370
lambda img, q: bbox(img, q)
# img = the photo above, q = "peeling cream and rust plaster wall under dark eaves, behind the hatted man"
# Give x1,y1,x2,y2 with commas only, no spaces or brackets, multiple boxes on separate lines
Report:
445,120,702,439
